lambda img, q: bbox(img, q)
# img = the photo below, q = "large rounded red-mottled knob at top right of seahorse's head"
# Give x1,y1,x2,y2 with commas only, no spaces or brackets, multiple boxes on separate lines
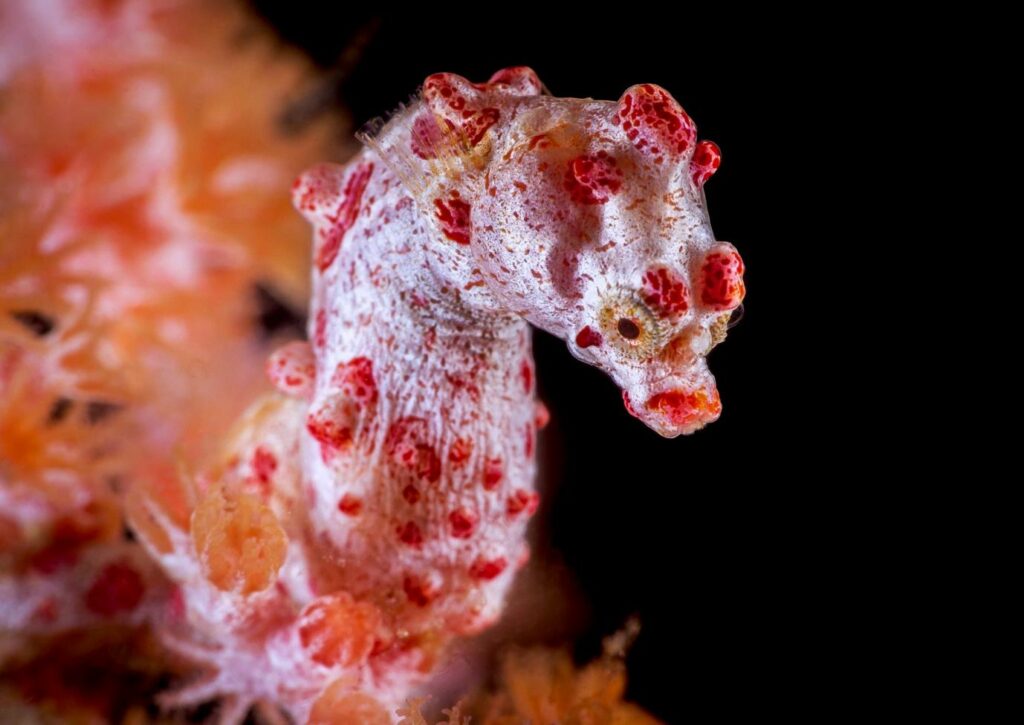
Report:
614,83,697,164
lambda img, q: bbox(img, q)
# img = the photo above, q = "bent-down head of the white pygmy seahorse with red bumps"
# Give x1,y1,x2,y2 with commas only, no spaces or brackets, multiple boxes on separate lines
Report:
366,68,744,437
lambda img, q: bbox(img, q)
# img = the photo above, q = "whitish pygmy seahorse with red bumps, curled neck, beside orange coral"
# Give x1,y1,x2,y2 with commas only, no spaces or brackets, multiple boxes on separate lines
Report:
132,68,743,720
